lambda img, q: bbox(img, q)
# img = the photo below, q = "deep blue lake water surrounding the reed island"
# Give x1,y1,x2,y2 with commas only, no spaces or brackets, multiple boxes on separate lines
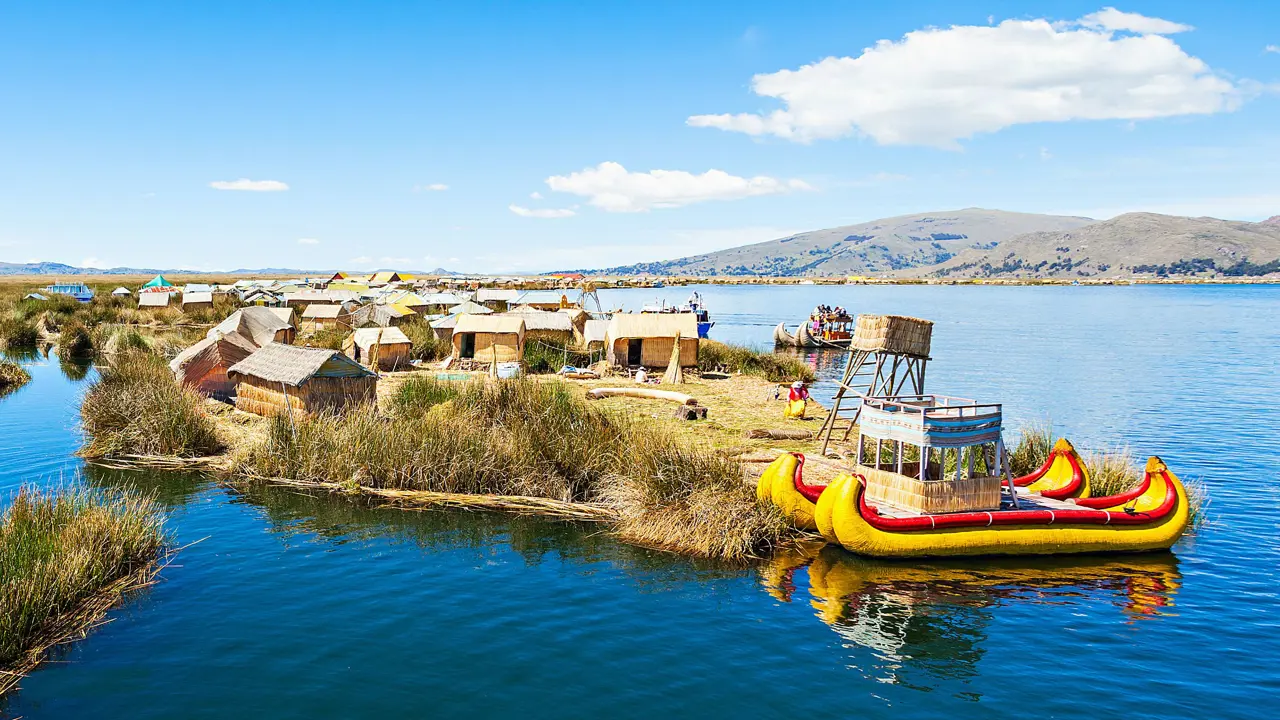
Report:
0,286,1280,719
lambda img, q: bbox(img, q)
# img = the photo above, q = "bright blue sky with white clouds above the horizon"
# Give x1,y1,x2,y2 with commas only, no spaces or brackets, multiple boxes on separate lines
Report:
0,0,1280,272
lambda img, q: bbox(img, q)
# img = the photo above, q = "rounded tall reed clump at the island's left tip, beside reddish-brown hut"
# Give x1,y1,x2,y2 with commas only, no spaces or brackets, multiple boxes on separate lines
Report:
81,351,223,459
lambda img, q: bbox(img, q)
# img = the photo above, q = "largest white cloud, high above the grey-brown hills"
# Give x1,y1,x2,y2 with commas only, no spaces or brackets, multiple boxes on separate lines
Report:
687,10,1252,149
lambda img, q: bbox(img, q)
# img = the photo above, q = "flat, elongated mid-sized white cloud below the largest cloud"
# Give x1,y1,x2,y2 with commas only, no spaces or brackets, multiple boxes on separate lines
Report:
547,163,813,213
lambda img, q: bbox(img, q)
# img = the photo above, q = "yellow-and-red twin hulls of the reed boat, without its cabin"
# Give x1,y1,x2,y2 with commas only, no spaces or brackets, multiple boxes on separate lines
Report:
756,450,1189,557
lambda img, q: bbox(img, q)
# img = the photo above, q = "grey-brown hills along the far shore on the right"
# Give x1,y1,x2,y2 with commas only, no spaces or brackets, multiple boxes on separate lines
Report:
576,208,1280,278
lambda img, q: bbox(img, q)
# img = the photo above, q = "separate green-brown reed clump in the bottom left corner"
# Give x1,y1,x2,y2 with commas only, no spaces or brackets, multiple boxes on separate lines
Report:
0,488,166,694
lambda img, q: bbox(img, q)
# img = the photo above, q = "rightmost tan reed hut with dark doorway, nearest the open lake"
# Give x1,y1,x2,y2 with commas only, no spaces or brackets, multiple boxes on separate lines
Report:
604,313,698,368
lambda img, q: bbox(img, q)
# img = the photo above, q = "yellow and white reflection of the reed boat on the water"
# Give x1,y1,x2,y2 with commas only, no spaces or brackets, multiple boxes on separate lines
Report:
760,543,1181,685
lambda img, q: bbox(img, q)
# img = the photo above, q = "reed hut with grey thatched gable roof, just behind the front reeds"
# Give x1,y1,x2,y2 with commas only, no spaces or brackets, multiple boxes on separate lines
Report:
227,343,378,416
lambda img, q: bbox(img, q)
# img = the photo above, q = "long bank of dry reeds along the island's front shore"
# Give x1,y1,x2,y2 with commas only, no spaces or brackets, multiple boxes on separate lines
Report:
234,377,792,560
